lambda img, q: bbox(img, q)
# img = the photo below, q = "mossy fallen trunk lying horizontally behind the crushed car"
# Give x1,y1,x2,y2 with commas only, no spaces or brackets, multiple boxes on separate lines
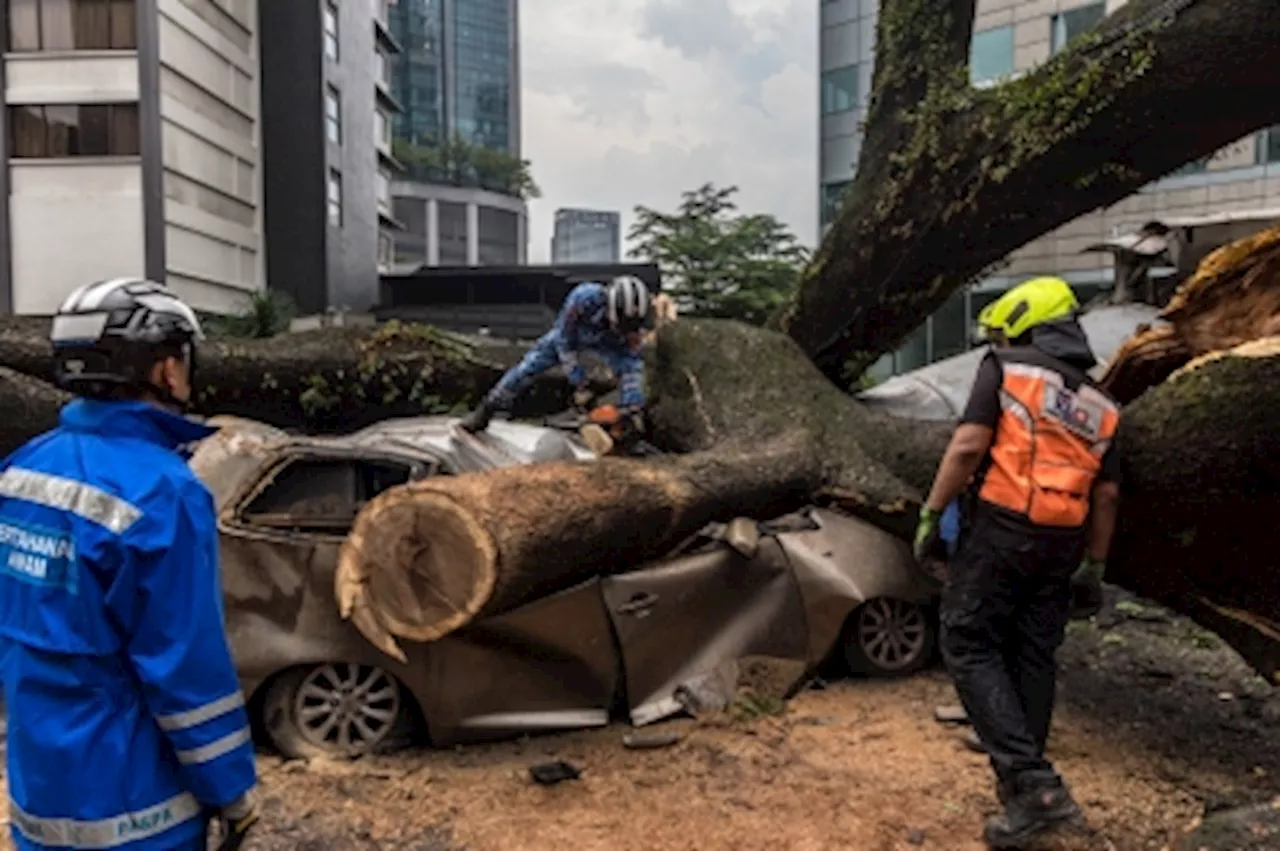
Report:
0,316,611,443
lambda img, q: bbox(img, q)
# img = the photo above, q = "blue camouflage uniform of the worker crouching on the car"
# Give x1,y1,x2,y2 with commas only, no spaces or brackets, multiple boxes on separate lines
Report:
486,282,645,411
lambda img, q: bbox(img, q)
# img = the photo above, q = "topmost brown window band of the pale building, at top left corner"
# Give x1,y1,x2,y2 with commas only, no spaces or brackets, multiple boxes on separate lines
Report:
6,0,138,52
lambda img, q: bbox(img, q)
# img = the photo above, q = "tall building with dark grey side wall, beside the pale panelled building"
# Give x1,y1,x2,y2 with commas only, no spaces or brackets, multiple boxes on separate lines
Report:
258,0,399,314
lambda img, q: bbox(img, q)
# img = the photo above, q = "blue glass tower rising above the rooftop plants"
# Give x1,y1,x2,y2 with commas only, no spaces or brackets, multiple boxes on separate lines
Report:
390,0,520,156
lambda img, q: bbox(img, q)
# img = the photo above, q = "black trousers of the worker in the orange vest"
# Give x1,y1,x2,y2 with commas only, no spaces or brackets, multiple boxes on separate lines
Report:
941,507,1084,788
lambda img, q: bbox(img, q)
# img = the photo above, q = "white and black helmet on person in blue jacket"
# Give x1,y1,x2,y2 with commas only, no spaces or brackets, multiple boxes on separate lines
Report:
50,278,205,402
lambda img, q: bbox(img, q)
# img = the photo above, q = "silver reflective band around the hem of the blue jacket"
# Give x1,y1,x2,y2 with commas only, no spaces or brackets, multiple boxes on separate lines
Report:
9,792,201,848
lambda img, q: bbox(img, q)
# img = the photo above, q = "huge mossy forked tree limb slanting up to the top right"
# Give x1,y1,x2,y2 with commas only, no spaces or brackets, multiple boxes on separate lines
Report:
777,0,1280,383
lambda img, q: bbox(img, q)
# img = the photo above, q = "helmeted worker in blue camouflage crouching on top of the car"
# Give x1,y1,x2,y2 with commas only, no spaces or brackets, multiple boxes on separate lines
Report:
460,275,649,433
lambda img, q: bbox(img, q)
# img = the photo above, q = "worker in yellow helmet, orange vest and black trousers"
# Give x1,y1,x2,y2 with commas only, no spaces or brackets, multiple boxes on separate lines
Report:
915,278,1120,848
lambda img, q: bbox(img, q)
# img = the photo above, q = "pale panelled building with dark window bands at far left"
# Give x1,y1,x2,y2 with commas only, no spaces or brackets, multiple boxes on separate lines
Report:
0,0,262,314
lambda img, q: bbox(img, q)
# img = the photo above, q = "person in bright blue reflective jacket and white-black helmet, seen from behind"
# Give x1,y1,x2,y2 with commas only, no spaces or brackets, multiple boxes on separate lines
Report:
0,279,256,851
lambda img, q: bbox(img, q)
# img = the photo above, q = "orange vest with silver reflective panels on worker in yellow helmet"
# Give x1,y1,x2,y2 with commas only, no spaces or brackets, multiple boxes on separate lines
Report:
978,352,1120,529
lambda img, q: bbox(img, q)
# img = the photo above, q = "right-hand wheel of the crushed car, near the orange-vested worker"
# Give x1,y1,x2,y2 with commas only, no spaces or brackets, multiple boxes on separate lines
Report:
844,596,937,677
